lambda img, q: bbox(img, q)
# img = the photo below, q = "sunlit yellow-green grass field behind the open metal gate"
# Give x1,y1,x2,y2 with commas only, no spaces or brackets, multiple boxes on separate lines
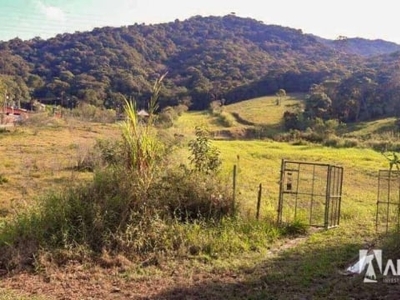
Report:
215,141,387,219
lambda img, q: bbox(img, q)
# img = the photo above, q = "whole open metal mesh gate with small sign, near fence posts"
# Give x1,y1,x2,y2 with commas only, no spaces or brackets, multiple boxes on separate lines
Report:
278,160,343,229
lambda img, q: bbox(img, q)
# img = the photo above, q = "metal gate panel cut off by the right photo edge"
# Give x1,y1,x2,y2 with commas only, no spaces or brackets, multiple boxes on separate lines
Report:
376,170,400,232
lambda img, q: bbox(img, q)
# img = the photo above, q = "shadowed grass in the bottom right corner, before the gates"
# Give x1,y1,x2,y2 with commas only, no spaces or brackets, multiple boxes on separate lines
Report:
150,228,400,300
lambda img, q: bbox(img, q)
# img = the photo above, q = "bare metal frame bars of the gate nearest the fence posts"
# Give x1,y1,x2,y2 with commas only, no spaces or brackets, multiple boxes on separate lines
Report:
277,159,344,229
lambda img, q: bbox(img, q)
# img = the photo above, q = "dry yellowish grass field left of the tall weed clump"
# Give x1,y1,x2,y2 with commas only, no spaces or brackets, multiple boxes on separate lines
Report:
0,121,120,216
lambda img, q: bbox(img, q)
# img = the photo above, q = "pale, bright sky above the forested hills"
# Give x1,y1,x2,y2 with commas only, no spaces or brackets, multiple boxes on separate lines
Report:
0,0,400,44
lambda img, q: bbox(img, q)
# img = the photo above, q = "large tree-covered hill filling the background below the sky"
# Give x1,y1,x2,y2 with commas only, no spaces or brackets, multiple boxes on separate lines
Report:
0,15,384,109
